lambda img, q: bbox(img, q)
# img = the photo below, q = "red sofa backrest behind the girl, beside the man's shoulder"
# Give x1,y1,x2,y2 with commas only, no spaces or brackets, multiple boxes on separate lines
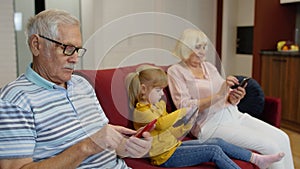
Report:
74,64,175,128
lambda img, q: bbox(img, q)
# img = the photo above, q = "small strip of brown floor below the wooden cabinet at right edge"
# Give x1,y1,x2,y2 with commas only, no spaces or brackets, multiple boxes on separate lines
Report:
282,128,300,169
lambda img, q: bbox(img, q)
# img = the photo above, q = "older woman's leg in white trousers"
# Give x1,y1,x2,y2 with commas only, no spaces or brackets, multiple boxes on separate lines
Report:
206,109,294,169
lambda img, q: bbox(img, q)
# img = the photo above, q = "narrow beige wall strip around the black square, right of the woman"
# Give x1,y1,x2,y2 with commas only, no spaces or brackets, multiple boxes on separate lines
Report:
222,0,255,76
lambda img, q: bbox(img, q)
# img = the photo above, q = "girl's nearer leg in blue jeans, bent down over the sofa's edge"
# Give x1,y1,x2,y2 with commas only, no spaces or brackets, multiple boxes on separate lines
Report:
160,143,240,169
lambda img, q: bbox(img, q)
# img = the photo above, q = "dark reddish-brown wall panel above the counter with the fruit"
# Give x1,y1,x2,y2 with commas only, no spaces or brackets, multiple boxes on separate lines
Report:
252,0,297,83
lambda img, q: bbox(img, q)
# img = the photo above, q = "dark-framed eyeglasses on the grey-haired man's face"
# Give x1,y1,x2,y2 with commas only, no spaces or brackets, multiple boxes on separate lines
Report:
39,34,86,57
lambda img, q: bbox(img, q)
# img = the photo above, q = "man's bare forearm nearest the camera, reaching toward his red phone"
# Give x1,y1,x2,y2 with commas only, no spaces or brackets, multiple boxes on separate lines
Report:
0,125,123,169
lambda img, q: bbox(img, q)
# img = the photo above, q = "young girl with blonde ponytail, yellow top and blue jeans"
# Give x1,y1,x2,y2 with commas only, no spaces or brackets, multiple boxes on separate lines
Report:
125,65,284,169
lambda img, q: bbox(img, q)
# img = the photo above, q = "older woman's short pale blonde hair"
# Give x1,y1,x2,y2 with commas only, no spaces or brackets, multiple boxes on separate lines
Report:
174,29,208,60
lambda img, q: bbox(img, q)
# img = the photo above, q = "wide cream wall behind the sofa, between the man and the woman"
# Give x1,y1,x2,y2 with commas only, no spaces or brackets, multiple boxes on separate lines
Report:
81,0,216,69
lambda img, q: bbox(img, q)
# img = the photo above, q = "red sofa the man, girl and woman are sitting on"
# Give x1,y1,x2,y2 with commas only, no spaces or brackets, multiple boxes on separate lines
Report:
74,63,281,169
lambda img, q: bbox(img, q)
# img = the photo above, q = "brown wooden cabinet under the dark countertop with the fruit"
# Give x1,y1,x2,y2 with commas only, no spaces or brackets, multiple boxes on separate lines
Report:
261,54,300,132
